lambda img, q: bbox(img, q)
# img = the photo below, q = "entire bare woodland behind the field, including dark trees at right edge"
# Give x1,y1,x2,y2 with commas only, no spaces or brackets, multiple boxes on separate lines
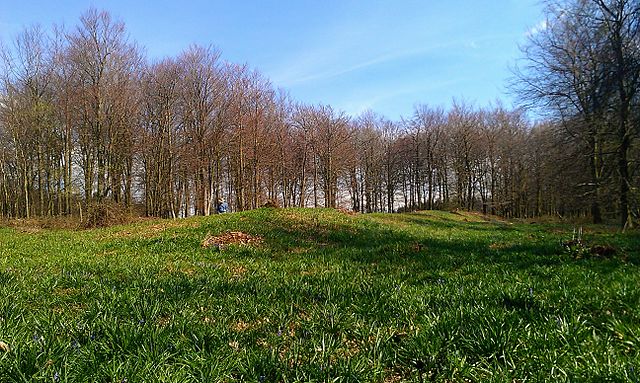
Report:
0,0,640,227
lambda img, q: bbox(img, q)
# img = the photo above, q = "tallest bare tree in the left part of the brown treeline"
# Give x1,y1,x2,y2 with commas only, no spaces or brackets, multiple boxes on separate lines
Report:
67,9,141,204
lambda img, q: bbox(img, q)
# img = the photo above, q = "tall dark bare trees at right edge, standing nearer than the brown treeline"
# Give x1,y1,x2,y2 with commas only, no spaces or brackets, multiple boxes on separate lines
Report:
515,0,640,226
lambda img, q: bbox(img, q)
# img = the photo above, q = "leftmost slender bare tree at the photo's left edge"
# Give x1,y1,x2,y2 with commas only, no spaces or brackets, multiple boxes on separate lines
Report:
0,27,62,218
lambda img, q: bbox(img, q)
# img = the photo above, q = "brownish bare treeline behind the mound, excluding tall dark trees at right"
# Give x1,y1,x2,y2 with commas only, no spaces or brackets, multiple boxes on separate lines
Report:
0,6,638,225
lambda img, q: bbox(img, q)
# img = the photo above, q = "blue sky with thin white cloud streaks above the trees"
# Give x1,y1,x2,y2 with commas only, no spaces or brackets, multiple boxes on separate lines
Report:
0,0,544,120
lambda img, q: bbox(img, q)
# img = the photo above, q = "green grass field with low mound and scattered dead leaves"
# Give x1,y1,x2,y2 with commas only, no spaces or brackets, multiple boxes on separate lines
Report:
0,209,640,383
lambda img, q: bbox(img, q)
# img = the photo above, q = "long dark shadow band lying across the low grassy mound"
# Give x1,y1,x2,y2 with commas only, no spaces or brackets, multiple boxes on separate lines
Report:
265,211,636,273
